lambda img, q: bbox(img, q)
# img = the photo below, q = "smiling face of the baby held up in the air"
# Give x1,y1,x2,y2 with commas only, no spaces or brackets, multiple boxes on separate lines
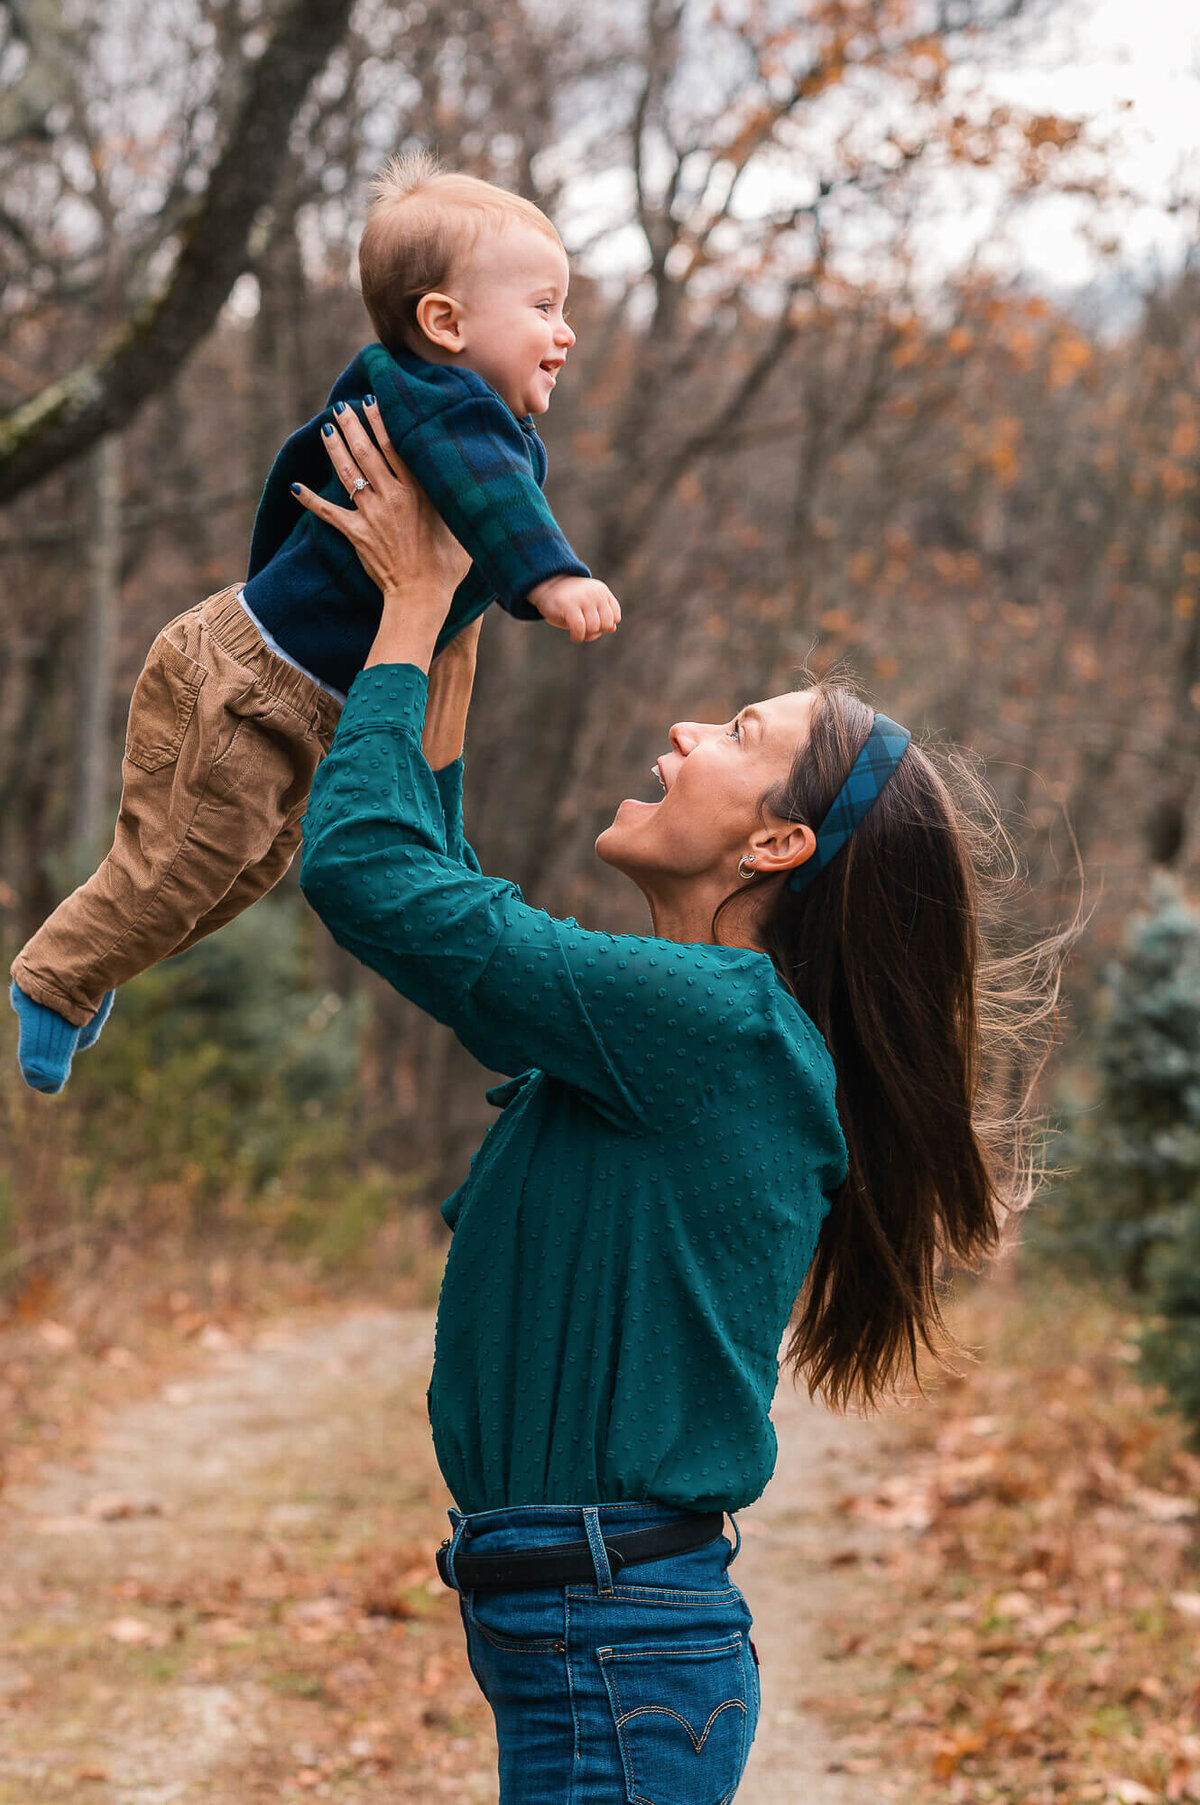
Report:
448,222,576,419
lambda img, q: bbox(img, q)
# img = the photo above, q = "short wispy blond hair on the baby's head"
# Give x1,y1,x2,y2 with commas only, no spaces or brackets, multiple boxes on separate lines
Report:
359,150,561,352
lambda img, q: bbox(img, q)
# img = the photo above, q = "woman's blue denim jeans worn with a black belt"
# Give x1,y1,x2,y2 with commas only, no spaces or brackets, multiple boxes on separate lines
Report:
440,1504,760,1805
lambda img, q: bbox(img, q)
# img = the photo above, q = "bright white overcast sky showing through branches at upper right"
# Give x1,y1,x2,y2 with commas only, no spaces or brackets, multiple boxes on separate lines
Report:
559,0,1200,308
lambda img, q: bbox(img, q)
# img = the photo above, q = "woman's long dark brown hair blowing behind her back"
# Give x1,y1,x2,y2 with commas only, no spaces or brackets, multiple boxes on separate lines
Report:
713,682,1070,1408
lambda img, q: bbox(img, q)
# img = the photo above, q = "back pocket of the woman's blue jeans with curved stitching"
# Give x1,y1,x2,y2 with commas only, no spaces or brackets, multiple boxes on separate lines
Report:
595,1634,749,1805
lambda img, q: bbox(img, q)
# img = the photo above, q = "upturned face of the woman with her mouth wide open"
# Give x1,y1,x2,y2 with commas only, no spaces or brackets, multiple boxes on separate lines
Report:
595,690,816,906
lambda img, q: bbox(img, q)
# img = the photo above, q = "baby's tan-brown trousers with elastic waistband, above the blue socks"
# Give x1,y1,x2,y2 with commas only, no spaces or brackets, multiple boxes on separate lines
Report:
13,590,337,1027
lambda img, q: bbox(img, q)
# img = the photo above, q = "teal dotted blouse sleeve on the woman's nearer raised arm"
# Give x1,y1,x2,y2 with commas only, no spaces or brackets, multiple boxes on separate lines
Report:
300,664,754,1132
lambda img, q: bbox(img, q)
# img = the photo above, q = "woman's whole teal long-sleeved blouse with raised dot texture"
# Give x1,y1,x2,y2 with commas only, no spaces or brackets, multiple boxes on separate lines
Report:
300,664,846,1513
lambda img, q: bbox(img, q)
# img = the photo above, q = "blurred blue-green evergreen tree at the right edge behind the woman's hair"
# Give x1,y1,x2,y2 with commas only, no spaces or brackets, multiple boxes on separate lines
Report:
1034,875,1200,1440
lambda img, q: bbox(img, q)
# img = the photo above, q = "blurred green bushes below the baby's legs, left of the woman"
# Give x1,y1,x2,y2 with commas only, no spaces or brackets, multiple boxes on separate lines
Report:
0,893,434,1265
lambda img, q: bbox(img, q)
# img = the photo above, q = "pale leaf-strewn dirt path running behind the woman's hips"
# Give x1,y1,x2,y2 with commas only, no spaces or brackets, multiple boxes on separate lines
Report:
0,1310,879,1805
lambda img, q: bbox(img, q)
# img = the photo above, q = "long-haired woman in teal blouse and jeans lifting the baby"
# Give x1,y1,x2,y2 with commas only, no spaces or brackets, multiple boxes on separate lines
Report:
298,408,1053,1805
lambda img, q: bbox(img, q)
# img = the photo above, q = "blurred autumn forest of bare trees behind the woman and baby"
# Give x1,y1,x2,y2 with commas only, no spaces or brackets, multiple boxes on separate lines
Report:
0,0,1200,1271
